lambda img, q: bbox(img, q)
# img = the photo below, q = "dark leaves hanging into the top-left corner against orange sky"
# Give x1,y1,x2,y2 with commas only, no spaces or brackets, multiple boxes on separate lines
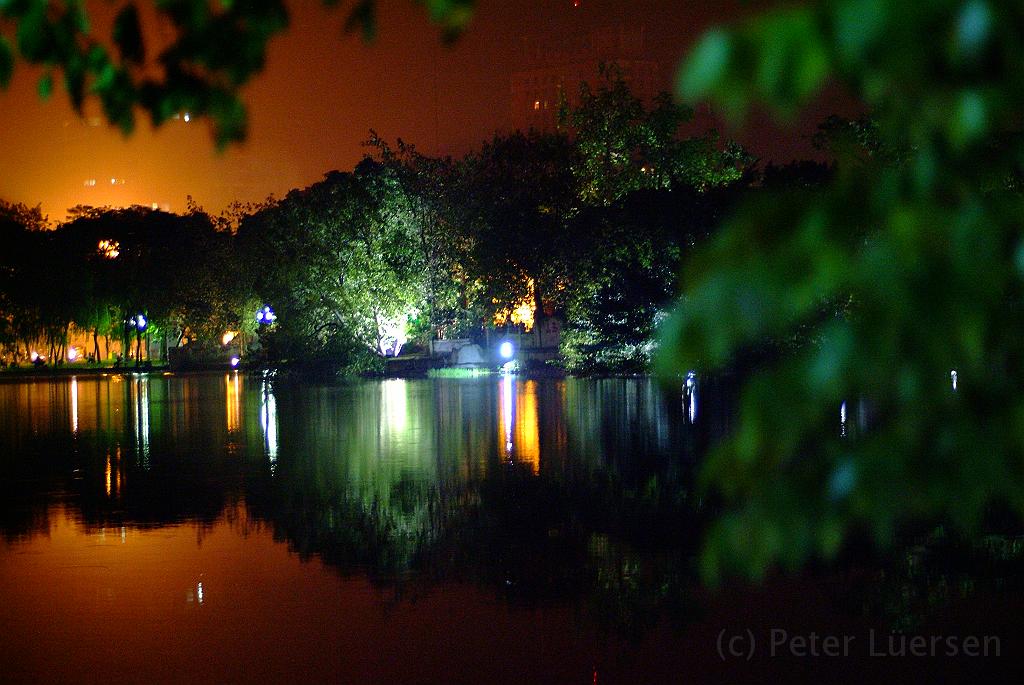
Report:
0,0,473,145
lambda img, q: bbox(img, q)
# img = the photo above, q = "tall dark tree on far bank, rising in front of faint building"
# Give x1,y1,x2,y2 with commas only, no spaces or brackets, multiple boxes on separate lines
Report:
561,73,753,372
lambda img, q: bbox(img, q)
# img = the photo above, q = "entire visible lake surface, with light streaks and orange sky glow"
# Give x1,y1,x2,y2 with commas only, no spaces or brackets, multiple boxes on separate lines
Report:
0,374,1014,683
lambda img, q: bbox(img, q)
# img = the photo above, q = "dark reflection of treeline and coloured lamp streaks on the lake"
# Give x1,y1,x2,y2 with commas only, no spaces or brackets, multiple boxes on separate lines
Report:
0,374,699,630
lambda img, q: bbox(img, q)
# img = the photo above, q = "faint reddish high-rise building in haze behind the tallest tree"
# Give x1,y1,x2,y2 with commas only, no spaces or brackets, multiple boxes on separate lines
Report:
512,27,658,131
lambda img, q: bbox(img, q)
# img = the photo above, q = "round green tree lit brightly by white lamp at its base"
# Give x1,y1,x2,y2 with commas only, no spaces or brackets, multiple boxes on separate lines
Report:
239,159,427,369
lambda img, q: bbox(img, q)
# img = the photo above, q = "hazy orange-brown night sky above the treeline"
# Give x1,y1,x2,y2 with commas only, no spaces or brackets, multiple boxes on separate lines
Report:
0,0,847,220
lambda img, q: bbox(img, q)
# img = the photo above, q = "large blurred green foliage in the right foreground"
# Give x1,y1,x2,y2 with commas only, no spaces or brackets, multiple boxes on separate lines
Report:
663,0,1024,576
